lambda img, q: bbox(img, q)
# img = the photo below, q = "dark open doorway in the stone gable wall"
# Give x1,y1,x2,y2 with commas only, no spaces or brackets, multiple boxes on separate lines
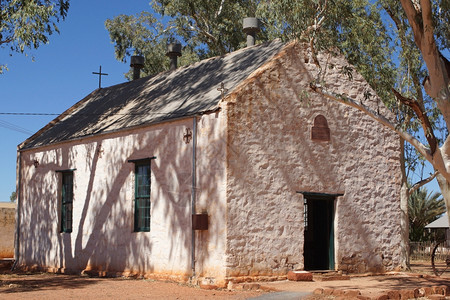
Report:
303,193,336,270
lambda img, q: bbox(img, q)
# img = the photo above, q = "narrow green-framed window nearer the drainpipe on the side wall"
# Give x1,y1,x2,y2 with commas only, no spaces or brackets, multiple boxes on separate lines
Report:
134,160,150,232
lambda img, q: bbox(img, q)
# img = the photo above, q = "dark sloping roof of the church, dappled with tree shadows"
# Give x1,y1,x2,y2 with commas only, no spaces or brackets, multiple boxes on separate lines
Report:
21,40,284,149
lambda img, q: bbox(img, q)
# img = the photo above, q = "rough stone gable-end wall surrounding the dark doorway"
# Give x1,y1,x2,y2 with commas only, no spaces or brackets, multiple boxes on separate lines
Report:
222,43,404,278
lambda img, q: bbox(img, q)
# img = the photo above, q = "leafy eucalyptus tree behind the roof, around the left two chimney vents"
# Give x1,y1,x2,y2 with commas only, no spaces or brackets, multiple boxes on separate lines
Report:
105,0,260,77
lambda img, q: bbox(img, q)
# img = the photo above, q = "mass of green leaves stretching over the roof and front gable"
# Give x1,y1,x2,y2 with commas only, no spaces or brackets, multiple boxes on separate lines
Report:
105,0,450,157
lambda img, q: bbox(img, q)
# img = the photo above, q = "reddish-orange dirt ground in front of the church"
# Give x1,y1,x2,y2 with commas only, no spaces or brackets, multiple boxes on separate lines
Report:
0,262,450,299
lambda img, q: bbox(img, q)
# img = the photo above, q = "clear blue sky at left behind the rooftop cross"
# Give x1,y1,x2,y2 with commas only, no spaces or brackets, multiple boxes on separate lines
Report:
0,0,150,201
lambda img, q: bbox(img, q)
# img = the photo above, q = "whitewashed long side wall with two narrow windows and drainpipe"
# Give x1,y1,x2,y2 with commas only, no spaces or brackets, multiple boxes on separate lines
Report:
19,114,229,280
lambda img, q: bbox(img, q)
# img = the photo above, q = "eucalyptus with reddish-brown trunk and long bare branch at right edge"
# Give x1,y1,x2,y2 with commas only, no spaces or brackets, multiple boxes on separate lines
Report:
311,0,450,226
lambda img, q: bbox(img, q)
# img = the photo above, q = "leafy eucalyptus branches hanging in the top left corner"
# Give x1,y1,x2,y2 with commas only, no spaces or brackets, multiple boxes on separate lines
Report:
0,0,69,74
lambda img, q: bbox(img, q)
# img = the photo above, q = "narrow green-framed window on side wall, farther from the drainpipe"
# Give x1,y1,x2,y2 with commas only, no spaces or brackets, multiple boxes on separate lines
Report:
61,172,73,232
